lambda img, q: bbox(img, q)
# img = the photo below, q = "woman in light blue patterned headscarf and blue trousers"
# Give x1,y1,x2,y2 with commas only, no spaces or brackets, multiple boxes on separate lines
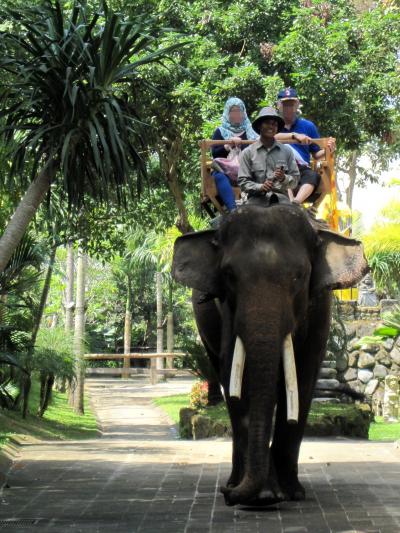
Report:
211,98,258,211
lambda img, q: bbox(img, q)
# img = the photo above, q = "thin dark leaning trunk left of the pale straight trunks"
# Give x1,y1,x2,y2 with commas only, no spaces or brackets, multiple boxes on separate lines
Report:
22,244,57,418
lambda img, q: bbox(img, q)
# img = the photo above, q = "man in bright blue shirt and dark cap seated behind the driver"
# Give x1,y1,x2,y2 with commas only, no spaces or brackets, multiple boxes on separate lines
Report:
276,87,336,204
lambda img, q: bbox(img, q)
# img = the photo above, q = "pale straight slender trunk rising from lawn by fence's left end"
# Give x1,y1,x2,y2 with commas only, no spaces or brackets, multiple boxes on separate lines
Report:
74,247,87,415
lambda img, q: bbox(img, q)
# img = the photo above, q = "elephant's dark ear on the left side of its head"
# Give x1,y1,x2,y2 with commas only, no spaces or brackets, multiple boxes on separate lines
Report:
172,230,221,296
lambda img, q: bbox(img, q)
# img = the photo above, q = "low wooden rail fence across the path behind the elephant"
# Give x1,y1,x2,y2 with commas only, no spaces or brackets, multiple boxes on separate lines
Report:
83,352,186,385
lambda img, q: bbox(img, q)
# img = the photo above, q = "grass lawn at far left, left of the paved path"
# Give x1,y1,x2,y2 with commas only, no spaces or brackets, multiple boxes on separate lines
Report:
0,381,99,447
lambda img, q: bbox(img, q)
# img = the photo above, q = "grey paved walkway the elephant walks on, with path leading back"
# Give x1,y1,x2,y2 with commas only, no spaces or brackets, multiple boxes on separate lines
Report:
0,379,400,533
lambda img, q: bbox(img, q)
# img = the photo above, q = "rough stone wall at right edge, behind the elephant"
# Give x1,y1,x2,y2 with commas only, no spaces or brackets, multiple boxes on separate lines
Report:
334,301,400,415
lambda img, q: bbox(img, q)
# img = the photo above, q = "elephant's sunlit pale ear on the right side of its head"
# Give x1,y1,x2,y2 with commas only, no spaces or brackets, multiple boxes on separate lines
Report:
311,229,369,293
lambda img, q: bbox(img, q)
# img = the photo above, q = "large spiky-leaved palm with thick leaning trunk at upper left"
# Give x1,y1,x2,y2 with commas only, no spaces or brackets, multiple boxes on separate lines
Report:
0,0,186,272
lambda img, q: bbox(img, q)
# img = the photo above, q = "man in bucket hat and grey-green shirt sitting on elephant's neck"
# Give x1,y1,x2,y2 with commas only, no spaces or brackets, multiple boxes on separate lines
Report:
238,107,299,201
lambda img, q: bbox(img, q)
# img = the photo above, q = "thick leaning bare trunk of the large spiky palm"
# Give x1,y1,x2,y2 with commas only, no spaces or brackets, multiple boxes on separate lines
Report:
0,162,56,272
